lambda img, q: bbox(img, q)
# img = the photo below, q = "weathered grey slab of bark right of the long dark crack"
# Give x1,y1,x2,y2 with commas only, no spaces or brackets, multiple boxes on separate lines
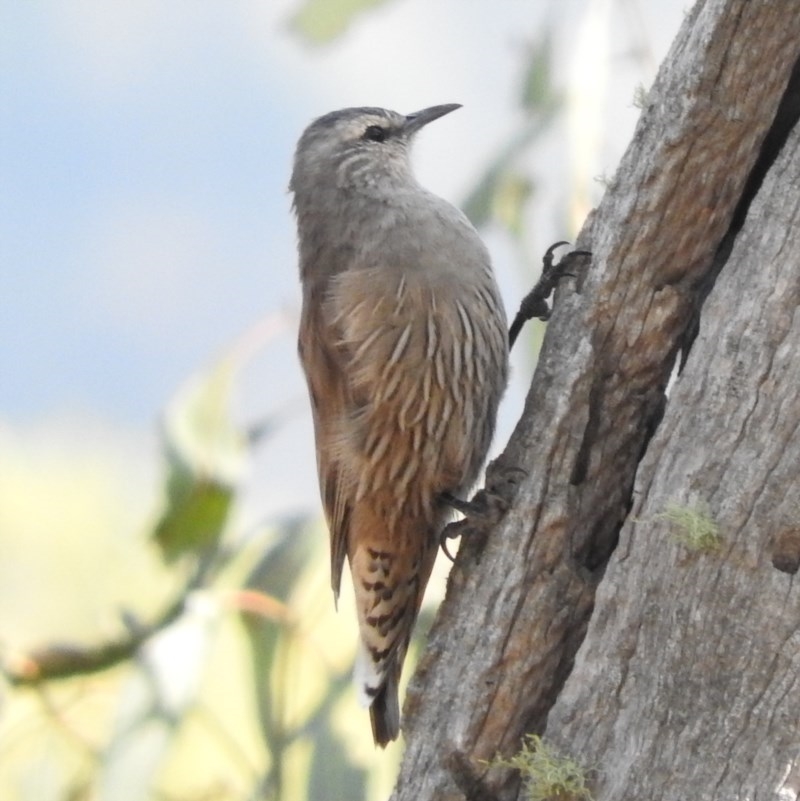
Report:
546,114,800,801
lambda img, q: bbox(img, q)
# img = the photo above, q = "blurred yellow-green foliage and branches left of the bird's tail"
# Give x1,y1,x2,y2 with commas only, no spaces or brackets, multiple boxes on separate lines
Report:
0,330,397,801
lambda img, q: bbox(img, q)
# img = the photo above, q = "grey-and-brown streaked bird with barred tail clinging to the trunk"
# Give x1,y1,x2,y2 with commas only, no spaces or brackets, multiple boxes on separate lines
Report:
289,103,509,747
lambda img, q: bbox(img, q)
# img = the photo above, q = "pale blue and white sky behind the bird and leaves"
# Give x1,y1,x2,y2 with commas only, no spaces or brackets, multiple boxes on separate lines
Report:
0,0,684,520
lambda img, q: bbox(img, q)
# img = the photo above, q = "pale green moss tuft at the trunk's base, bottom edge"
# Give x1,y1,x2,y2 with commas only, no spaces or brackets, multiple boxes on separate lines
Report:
491,734,592,801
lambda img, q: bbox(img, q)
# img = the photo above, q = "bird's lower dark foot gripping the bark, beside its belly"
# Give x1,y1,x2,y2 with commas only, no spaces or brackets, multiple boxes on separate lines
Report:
439,457,526,562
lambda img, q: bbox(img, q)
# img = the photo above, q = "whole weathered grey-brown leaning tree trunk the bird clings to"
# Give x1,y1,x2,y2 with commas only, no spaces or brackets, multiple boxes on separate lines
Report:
392,0,800,801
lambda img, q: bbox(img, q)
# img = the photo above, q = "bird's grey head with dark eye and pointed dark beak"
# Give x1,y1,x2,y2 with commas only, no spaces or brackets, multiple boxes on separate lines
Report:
289,103,461,202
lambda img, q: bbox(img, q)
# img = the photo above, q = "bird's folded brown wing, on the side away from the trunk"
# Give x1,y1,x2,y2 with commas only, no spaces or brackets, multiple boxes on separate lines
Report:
299,269,438,596
